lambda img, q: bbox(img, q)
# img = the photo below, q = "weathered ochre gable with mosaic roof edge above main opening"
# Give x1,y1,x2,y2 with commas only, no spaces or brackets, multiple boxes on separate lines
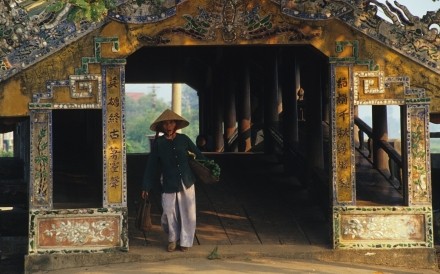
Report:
0,0,440,116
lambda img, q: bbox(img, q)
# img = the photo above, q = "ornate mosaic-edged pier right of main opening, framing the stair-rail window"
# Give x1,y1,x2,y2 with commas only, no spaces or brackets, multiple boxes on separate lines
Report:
330,41,433,249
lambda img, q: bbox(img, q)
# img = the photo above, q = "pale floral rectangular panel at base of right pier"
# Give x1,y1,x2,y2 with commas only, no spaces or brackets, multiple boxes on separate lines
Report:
333,206,434,249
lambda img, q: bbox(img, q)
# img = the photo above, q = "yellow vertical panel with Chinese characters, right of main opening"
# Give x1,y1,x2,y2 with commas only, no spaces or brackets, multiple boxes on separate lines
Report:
332,66,355,204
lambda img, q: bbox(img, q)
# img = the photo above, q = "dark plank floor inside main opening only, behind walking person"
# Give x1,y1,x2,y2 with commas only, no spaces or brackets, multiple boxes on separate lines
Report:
129,155,329,247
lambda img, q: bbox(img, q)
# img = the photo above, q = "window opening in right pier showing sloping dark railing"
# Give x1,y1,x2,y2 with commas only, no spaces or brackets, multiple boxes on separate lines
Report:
355,105,405,206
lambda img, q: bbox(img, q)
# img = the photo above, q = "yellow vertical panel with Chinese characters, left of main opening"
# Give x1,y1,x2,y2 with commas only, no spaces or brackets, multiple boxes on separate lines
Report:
103,66,126,206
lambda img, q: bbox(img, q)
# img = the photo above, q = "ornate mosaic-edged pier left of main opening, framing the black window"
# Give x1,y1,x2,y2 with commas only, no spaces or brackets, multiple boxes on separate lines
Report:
28,37,128,256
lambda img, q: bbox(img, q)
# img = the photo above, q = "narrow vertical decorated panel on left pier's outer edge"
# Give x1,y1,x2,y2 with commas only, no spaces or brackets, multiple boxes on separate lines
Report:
29,110,53,209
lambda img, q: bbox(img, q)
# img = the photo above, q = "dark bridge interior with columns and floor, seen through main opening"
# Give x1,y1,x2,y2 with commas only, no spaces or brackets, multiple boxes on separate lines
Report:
125,46,330,246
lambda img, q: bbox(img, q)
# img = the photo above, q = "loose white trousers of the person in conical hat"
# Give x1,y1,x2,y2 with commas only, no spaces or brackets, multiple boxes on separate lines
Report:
161,185,196,247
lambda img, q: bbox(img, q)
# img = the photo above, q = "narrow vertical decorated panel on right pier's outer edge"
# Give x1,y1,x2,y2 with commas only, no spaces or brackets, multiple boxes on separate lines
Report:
407,105,431,205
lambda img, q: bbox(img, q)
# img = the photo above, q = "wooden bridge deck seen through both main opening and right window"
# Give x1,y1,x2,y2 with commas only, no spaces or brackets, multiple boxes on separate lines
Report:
129,154,402,250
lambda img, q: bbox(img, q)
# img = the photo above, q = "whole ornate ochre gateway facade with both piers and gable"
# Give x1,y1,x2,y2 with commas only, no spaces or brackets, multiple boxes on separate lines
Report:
0,0,440,264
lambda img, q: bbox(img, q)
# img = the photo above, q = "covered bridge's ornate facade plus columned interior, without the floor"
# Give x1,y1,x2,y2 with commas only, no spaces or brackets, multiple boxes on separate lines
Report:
0,0,440,272
